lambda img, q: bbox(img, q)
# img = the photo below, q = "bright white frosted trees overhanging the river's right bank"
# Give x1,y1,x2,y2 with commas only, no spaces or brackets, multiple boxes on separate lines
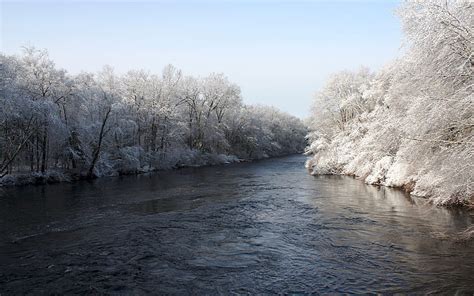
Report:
306,1,474,205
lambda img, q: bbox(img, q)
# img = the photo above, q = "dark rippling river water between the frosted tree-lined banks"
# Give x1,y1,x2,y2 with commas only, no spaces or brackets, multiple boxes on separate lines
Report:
0,156,474,295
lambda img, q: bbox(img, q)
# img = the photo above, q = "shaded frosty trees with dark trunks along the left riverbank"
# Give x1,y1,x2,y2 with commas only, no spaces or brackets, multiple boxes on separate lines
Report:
0,51,308,185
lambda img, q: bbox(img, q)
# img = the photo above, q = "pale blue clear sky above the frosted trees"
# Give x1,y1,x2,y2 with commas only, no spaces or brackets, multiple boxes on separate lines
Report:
0,0,401,118
